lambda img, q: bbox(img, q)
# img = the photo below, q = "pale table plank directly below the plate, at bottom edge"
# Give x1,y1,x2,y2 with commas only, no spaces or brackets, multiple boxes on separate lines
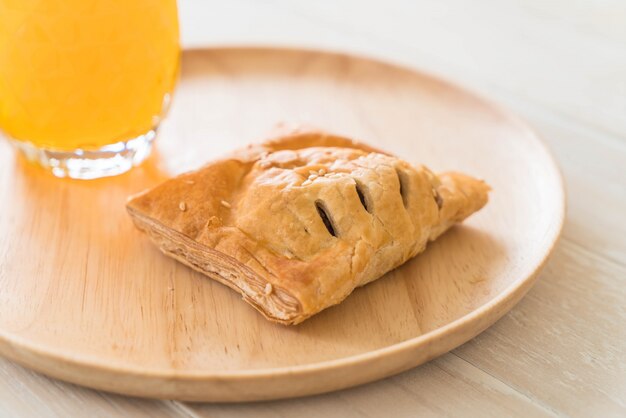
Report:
185,354,555,418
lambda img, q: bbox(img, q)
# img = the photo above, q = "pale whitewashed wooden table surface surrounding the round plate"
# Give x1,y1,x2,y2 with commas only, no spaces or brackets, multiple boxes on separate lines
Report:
0,0,626,417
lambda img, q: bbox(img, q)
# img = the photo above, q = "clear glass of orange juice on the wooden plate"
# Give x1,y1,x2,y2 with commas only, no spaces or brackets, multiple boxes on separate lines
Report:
0,0,180,179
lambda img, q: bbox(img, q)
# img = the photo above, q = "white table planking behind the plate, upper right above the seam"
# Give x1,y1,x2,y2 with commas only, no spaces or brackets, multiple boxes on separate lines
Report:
181,0,626,138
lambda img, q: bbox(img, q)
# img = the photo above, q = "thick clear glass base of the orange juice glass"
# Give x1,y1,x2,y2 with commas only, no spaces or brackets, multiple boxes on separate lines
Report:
11,129,156,180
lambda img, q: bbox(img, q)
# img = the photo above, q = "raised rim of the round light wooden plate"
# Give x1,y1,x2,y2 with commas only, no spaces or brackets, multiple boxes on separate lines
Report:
0,43,567,400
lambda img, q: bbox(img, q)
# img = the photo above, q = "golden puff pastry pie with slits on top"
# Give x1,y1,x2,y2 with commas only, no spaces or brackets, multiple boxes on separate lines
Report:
127,132,489,324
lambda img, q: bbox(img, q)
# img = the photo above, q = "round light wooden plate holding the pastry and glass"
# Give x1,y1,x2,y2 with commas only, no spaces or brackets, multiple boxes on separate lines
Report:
0,49,564,401
